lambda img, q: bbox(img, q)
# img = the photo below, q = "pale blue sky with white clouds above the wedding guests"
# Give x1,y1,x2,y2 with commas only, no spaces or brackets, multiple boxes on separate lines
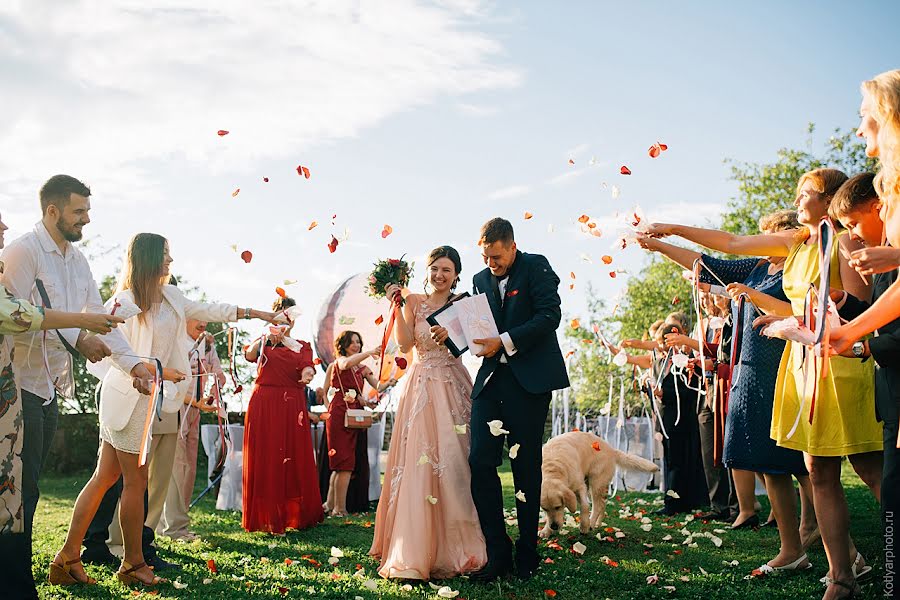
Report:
0,0,900,390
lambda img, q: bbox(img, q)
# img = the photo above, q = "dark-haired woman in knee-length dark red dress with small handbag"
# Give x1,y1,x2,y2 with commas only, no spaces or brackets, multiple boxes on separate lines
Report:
322,331,397,517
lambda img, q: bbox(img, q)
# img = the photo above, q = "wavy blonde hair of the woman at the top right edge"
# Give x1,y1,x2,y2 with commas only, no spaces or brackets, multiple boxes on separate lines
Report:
861,69,900,204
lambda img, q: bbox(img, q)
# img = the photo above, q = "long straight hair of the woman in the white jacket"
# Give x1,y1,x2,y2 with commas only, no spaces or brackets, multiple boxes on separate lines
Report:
116,233,169,323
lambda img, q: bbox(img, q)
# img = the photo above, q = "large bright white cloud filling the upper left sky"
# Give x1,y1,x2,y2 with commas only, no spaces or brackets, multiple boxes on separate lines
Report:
0,0,521,203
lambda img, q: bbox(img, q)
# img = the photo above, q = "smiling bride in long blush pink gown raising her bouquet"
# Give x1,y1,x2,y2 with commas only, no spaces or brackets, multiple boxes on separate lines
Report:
369,246,487,580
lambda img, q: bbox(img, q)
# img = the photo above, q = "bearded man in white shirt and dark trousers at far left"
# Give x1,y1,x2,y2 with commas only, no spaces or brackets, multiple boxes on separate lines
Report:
0,175,151,564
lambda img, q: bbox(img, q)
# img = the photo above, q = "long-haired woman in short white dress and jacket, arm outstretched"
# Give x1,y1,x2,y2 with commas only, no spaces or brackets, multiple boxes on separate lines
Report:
49,233,276,586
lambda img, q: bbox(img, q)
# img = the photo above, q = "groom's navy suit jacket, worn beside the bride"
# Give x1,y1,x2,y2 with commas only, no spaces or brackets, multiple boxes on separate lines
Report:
472,251,569,399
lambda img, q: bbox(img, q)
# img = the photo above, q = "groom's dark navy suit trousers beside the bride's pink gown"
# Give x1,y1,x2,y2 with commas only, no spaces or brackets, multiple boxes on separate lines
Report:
469,365,550,570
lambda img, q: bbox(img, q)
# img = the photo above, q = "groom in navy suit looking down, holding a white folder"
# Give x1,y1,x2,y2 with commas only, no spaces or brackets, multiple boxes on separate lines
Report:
450,218,569,581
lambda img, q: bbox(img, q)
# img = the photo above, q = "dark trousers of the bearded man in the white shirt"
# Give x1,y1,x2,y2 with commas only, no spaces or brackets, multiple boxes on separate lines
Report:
22,390,59,564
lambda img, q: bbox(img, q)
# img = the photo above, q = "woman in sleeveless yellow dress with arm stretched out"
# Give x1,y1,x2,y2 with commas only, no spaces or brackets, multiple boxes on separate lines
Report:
648,169,882,599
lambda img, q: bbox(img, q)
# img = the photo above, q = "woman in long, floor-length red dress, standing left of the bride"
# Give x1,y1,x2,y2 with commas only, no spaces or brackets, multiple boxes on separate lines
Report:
242,298,324,535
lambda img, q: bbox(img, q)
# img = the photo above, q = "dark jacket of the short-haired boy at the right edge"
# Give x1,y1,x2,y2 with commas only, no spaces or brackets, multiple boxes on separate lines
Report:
869,269,900,421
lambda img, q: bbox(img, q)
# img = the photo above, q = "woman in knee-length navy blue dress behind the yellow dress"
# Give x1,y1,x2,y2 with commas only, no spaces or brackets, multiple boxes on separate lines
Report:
639,210,818,573
